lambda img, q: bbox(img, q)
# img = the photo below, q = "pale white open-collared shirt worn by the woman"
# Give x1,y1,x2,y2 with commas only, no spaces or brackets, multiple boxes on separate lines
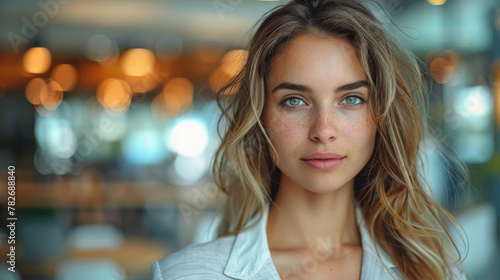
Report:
151,207,464,280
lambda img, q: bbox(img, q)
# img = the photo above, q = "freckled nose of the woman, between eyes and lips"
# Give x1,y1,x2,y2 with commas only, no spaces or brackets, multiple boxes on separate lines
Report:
309,106,337,143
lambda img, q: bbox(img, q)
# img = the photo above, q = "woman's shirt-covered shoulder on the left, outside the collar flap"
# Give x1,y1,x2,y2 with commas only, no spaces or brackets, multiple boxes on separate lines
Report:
151,235,235,280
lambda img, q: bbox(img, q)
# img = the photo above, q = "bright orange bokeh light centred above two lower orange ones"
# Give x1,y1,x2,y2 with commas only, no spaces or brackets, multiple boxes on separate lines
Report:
121,49,156,77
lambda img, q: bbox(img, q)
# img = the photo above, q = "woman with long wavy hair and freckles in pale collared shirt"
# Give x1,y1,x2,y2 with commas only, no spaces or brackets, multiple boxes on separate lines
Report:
152,0,465,279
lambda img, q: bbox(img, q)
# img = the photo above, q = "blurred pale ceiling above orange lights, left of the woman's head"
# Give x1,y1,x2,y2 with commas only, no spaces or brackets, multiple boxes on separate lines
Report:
0,0,279,52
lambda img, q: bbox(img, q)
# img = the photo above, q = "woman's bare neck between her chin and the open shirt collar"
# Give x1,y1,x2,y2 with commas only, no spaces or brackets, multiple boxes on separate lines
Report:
267,178,361,253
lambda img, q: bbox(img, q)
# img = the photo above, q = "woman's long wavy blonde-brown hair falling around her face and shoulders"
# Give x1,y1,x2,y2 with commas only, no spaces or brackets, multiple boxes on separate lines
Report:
212,0,465,279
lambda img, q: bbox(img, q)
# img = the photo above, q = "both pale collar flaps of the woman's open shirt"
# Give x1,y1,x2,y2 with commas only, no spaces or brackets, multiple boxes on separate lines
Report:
224,202,397,279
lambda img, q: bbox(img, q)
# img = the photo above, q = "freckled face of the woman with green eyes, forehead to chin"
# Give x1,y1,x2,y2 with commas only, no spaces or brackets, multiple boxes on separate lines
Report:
262,34,377,193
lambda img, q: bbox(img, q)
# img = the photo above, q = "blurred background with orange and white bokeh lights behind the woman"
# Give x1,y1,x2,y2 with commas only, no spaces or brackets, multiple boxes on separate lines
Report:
0,0,500,280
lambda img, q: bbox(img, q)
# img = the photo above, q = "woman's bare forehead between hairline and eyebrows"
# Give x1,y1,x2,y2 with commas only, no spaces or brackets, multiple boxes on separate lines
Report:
267,34,366,87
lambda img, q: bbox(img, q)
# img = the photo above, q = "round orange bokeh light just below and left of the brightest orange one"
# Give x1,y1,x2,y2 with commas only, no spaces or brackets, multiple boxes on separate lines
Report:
96,78,132,113
